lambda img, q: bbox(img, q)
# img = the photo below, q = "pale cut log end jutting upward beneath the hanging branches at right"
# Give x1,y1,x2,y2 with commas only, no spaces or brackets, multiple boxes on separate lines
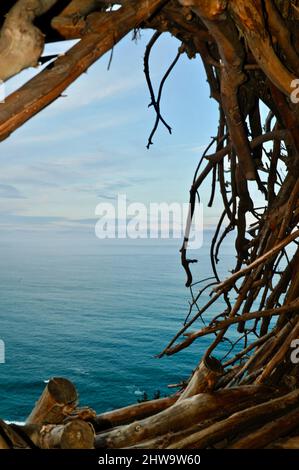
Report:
178,357,223,402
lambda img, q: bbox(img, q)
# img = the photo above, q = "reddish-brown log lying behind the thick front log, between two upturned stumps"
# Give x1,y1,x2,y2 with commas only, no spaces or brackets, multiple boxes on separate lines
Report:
92,395,178,431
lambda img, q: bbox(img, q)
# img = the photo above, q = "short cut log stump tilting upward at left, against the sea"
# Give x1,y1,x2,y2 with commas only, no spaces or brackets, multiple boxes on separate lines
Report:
26,377,78,424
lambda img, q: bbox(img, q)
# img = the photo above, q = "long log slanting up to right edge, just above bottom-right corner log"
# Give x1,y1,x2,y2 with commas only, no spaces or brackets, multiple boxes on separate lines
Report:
169,390,299,449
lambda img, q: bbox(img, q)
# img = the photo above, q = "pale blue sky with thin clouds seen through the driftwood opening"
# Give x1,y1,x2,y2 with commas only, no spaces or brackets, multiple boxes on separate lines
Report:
0,31,224,239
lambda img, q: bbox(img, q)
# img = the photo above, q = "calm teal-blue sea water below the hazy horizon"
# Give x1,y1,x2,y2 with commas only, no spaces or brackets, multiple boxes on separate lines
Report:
0,232,234,421
